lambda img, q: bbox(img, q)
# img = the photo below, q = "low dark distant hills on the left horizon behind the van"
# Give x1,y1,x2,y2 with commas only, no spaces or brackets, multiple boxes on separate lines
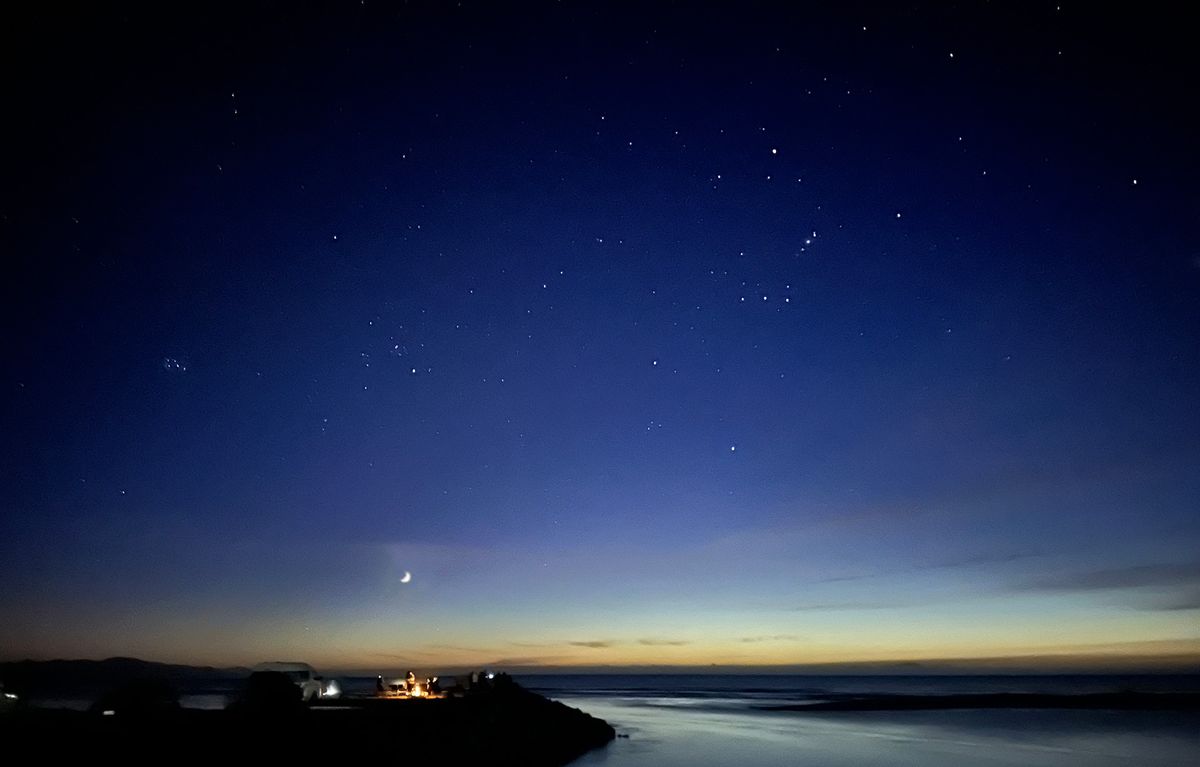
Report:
0,658,250,696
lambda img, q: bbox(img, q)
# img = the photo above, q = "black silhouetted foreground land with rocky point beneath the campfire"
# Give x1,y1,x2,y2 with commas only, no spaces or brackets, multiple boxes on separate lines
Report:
0,684,614,767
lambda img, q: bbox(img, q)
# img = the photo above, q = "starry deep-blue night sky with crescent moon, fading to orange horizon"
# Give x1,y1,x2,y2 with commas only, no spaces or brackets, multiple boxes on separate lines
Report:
0,0,1200,669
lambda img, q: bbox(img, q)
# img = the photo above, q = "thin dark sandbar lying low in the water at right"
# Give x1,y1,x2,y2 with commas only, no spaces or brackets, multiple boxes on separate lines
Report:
758,693,1200,712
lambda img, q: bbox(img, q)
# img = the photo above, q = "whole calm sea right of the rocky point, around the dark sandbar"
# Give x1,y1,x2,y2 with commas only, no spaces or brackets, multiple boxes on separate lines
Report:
517,675,1200,767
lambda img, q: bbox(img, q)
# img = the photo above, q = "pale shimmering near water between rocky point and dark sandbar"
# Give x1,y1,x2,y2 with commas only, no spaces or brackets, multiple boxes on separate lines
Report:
556,695,1200,767
